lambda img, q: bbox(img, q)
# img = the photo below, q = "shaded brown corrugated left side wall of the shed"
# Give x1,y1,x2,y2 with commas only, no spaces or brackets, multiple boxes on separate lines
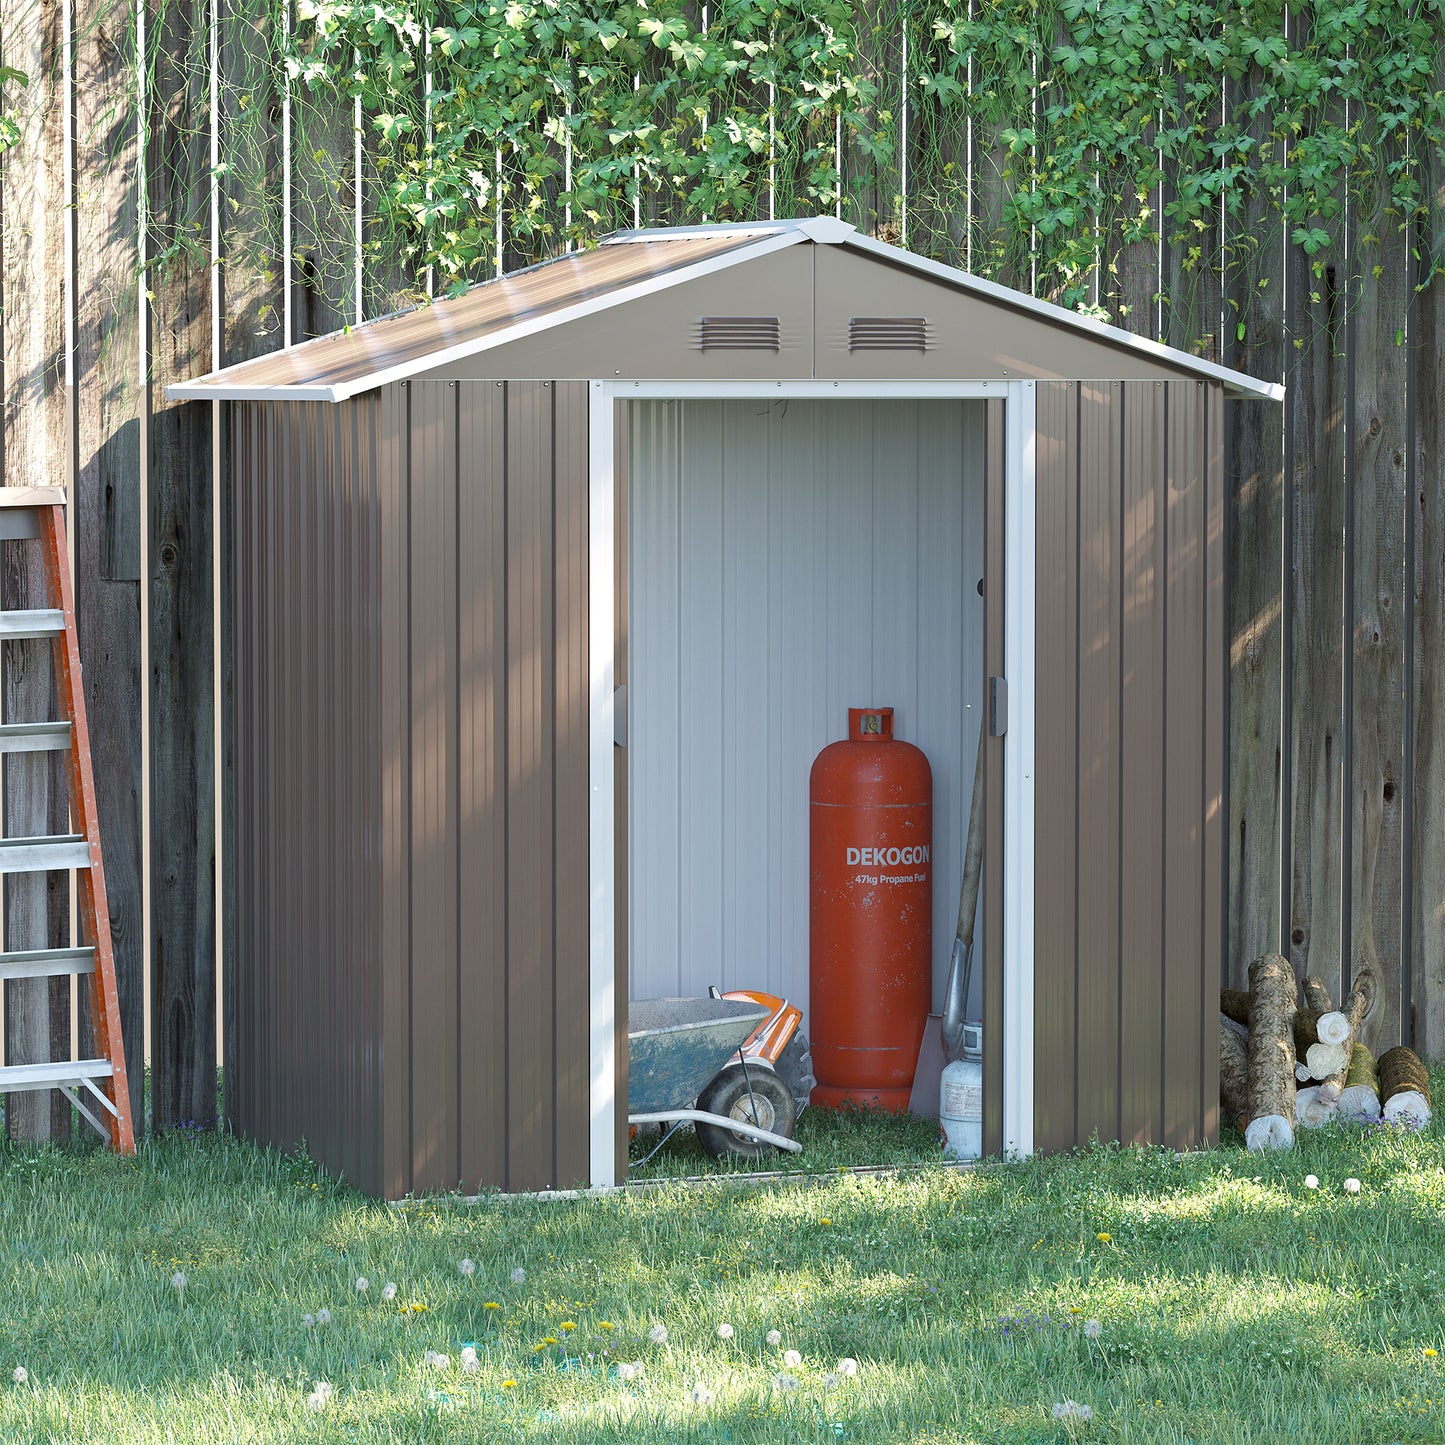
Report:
230,399,381,1189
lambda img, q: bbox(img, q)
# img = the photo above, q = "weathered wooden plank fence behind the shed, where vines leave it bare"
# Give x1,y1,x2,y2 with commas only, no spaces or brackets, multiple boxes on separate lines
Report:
0,0,1445,1133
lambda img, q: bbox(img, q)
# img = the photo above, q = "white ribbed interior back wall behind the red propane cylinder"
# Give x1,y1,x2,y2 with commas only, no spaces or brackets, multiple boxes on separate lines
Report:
629,400,984,1027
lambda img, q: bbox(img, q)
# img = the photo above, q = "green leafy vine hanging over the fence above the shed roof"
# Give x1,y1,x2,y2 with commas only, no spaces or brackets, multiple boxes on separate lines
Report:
200,0,1445,348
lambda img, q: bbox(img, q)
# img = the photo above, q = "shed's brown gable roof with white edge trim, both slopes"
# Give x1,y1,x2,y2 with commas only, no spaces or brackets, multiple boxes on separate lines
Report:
166,217,1283,402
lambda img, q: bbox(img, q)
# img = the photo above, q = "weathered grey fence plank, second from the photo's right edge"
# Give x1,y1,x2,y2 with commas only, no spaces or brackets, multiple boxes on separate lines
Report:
1347,171,1410,1053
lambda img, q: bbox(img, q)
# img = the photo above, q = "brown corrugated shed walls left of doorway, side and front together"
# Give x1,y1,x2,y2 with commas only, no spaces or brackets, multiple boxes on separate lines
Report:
233,381,591,1196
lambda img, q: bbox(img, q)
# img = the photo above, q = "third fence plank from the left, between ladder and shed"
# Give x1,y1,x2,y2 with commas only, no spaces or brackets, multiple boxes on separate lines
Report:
145,0,215,1129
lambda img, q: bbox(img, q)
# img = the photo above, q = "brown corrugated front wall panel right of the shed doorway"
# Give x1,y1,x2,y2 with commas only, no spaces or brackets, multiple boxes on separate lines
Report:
1035,381,1224,1149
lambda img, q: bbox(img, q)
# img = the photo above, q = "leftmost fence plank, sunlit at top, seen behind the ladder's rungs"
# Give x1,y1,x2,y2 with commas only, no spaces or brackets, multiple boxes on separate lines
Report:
0,0,71,1140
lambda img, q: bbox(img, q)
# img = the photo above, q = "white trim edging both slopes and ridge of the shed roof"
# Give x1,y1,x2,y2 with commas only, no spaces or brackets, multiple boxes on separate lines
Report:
166,215,1285,402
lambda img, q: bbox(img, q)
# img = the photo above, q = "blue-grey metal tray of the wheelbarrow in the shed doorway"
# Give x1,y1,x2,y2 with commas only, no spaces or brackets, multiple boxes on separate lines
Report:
627,998,767,1117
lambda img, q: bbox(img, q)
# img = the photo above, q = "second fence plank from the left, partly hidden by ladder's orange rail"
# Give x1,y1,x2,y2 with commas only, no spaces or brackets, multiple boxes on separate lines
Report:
68,0,146,1123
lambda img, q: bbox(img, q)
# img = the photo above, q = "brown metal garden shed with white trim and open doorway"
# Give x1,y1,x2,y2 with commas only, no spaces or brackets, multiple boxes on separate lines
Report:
169,218,1280,1196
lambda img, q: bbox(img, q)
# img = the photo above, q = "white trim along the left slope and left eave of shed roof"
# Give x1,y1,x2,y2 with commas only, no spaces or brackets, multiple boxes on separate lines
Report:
166,227,808,402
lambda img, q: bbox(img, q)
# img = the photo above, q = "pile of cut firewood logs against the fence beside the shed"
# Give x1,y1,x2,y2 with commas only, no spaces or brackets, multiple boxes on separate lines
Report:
1220,954,1431,1150
